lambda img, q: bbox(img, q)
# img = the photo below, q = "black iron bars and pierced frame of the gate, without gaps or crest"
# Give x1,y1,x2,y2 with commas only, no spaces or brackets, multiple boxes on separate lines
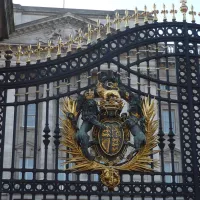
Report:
0,21,200,200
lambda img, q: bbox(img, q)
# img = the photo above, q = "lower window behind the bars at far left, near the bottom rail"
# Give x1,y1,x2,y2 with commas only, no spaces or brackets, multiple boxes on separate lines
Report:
19,158,33,180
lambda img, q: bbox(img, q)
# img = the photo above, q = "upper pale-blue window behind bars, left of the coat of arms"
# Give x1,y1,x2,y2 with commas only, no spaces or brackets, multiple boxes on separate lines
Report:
23,104,36,127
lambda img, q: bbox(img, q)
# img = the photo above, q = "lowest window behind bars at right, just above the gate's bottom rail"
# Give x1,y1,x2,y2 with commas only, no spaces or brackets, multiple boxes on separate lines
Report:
164,162,180,183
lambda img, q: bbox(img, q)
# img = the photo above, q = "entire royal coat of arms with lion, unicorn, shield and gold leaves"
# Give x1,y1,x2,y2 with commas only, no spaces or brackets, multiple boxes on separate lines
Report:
62,74,158,190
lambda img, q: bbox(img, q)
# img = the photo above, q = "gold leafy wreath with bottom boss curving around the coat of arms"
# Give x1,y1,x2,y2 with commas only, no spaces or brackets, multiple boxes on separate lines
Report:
61,98,159,189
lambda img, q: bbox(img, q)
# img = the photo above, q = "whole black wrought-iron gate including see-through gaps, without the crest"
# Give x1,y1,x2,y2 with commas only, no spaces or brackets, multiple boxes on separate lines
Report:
0,3,200,200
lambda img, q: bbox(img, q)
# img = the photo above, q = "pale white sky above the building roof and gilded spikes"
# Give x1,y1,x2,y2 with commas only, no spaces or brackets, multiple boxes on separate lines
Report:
13,0,200,23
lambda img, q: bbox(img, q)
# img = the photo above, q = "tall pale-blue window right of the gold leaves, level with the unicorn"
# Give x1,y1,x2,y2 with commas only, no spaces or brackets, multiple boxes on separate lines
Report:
162,110,175,134
